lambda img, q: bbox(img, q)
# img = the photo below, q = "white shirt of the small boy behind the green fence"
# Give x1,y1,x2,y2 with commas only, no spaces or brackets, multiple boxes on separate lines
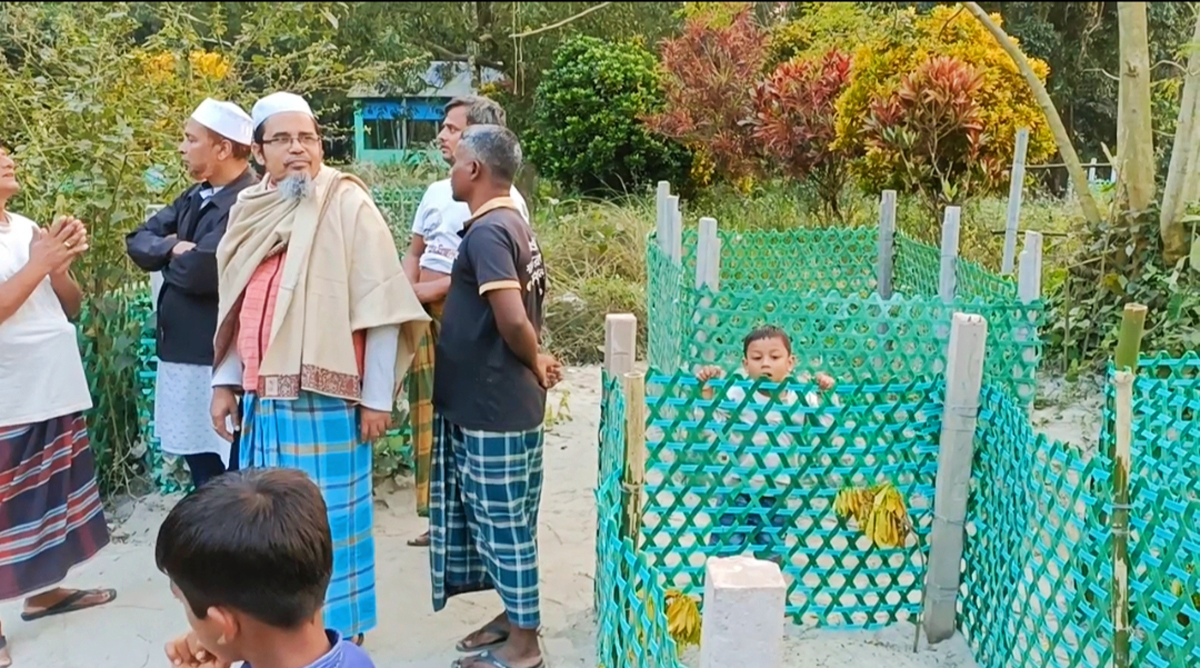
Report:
700,372,841,491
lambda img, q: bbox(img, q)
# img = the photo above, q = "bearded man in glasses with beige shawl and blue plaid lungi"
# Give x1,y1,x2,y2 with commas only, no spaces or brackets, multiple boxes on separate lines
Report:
211,92,430,644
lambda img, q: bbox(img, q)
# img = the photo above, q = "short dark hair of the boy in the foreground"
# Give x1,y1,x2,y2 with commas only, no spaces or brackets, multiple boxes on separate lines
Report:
155,469,334,628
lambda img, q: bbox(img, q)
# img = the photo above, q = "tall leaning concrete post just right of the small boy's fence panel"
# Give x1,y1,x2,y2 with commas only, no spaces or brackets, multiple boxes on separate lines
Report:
924,313,988,644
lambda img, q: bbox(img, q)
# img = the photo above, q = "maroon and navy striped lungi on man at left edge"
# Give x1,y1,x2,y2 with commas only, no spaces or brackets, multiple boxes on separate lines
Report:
0,413,108,601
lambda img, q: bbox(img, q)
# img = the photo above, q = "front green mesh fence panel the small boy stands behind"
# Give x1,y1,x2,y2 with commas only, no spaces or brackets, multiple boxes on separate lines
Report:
642,369,942,627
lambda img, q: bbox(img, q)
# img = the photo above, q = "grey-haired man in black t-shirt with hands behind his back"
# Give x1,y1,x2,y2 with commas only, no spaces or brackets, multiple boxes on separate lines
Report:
430,125,562,668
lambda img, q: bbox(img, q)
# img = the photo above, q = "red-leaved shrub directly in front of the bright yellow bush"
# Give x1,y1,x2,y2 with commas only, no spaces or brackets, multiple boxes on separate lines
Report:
863,56,1007,218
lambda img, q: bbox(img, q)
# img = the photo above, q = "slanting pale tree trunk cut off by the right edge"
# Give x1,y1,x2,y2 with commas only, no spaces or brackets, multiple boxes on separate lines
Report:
1158,12,1200,266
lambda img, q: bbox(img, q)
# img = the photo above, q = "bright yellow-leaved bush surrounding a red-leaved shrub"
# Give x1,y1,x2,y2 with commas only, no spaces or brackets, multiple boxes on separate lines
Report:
836,6,1055,223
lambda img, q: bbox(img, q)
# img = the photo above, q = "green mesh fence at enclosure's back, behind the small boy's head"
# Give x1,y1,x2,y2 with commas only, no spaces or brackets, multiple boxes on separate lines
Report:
647,229,1044,405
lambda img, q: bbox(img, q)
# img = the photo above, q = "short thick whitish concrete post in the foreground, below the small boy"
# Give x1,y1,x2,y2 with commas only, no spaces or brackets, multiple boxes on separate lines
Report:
700,556,787,668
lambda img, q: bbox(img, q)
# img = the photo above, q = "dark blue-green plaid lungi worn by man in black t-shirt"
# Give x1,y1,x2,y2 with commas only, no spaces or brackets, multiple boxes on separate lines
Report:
430,415,542,628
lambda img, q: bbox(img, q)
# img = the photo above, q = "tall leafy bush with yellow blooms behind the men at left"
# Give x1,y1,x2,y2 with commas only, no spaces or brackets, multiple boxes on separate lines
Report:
0,2,403,491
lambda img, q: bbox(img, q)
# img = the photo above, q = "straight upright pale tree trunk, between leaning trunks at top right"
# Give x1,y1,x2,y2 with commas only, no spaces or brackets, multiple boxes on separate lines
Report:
1117,2,1154,211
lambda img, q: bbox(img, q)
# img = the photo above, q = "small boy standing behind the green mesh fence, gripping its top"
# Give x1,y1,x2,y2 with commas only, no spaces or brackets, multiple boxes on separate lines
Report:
696,326,834,566
